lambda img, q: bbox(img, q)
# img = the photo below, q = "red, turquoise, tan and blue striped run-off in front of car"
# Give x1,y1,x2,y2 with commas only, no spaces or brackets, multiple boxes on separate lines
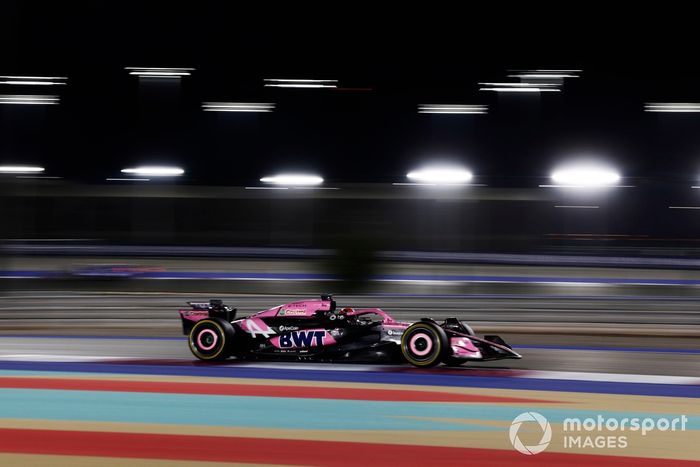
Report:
0,346,700,466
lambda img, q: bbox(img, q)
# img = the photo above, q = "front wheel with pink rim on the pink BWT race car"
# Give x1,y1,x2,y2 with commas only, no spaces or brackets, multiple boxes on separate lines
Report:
401,321,450,368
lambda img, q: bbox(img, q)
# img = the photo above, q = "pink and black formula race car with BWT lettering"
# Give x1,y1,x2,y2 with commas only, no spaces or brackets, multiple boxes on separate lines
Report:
180,294,521,367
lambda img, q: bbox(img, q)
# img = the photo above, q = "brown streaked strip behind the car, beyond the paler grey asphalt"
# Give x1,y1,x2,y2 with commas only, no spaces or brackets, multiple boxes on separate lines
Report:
0,286,700,328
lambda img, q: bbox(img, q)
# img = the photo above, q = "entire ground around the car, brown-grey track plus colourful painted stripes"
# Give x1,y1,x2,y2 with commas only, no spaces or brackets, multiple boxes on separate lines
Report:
0,292,700,467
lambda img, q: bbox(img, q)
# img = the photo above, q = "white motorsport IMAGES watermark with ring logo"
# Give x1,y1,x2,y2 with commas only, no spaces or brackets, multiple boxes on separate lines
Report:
508,412,688,456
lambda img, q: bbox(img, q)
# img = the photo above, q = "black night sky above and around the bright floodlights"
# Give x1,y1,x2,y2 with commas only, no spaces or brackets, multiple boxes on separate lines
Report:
0,1,700,186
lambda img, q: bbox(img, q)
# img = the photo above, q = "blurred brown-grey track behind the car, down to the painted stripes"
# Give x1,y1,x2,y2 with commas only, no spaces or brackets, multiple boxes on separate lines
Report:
0,292,700,376
